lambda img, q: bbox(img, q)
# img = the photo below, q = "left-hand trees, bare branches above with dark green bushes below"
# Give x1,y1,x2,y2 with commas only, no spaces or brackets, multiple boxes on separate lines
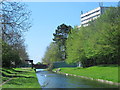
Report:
0,0,31,68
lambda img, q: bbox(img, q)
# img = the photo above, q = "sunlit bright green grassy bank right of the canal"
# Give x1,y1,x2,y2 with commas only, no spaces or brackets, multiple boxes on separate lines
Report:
53,65,120,83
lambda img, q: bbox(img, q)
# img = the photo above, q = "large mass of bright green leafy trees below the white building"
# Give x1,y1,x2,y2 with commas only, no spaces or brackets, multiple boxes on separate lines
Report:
66,7,120,67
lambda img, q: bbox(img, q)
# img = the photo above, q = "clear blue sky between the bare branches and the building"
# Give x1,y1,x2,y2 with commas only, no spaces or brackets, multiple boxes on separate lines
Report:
25,2,117,63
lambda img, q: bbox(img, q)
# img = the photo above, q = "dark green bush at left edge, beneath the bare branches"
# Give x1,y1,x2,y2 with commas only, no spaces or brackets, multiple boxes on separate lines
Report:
2,42,21,67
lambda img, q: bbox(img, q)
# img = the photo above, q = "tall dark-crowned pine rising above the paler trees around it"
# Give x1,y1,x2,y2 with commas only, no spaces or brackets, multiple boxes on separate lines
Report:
53,24,72,60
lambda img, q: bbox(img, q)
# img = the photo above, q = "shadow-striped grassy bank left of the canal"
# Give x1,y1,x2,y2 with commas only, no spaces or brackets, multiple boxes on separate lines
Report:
0,68,40,88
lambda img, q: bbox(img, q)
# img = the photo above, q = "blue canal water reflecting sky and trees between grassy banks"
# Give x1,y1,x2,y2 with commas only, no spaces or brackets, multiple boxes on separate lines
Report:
36,69,116,88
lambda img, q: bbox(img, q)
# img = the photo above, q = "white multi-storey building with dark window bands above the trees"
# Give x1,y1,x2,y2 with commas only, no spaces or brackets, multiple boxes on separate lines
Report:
78,7,109,27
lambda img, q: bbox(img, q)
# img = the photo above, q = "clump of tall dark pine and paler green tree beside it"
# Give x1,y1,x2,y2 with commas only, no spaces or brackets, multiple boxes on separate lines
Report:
42,24,72,69
